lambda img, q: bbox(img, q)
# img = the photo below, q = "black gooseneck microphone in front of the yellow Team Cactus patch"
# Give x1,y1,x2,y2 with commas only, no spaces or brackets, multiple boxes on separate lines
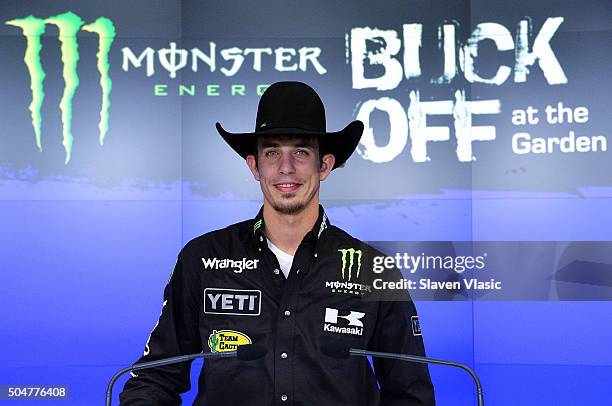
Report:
106,344,268,406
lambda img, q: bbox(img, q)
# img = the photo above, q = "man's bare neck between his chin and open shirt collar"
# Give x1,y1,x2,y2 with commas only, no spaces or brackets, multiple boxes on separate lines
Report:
263,203,319,255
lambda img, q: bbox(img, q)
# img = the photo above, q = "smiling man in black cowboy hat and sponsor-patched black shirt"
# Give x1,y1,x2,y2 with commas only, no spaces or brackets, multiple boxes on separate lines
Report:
120,82,434,406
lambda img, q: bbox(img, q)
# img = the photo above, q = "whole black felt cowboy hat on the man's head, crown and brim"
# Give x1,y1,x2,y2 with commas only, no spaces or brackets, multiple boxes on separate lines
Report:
216,82,363,169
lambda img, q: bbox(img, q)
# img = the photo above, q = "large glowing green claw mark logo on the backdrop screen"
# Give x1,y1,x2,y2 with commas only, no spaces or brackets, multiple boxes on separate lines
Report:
6,11,115,164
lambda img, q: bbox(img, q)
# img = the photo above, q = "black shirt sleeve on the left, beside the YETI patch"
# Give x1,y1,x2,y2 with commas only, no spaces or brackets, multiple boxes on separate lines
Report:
119,255,202,406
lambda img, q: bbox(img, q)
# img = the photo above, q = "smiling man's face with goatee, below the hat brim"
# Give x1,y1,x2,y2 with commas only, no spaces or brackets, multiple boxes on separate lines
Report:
247,136,335,214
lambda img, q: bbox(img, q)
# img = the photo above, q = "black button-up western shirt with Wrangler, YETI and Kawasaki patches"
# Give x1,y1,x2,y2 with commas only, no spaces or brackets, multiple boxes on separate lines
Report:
120,207,434,406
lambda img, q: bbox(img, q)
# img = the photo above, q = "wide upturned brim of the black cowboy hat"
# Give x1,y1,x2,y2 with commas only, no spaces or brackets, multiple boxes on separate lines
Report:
215,120,363,169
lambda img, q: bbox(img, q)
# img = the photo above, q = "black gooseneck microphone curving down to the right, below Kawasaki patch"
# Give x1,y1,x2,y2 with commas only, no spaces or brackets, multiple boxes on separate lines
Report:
321,341,484,406
